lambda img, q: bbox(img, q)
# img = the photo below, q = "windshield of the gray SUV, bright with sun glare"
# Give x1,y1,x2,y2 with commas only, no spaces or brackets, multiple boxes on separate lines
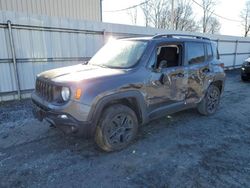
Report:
89,40,147,68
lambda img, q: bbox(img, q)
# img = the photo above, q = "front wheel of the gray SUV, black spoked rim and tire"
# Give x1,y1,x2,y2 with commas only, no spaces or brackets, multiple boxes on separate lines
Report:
95,104,138,151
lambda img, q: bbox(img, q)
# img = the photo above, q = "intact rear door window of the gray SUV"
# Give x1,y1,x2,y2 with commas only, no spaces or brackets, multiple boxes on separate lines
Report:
187,42,205,65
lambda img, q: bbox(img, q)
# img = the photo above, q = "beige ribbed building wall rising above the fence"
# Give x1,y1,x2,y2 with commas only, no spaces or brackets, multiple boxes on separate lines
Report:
0,0,101,21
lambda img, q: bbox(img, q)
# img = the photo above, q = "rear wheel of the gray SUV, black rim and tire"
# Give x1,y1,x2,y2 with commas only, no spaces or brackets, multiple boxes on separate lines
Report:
197,85,221,116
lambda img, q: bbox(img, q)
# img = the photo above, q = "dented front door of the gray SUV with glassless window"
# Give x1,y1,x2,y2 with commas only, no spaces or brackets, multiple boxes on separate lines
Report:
147,43,188,116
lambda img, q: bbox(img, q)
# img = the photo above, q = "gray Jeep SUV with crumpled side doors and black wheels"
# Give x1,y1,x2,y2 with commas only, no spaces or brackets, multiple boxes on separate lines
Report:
32,35,225,151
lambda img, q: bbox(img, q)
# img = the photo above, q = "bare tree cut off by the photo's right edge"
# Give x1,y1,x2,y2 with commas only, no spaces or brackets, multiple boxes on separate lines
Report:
240,0,250,37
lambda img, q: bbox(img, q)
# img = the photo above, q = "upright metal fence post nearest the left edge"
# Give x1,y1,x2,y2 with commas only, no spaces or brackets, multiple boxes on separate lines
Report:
7,20,21,100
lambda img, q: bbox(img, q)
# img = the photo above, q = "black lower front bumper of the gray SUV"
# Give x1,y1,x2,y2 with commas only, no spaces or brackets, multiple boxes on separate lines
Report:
32,96,94,137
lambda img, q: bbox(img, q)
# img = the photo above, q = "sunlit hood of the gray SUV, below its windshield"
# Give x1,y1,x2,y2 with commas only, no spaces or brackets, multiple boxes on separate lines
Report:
38,64,124,82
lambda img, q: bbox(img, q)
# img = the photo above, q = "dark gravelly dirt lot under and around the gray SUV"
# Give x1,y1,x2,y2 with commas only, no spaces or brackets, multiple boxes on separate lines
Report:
0,71,250,187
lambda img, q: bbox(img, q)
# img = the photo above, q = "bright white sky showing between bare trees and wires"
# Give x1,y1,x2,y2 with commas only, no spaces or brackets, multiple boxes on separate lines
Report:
103,0,246,36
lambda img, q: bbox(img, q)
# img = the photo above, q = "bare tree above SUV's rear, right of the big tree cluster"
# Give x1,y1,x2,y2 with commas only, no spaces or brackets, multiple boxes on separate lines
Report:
199,0,220,33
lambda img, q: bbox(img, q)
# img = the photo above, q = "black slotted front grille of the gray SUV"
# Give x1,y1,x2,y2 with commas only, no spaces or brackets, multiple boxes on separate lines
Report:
36,79,57,102
